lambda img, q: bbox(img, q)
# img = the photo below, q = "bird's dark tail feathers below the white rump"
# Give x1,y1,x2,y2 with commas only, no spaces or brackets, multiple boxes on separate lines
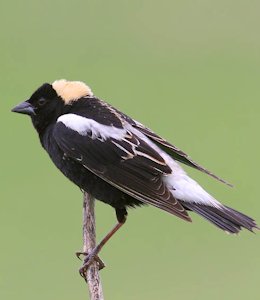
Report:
180,201,259,233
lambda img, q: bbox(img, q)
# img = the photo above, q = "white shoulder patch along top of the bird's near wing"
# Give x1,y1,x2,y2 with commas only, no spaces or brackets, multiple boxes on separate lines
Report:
57,114,126,140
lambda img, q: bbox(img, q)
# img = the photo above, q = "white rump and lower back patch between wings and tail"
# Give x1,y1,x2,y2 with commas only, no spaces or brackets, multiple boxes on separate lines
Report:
127,127,222,208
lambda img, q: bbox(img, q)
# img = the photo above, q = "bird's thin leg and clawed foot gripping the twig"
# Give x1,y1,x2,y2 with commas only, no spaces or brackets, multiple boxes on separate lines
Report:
79,209,127,277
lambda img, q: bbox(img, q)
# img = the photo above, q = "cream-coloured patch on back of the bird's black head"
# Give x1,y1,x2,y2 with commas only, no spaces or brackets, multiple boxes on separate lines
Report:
52,79,93,104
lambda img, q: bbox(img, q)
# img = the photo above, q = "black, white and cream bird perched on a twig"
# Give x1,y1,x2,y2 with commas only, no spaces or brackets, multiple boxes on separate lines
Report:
12,79,259,274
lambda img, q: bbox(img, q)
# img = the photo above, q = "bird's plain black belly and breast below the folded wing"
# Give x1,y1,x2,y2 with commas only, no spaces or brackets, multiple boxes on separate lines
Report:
42,132,144,209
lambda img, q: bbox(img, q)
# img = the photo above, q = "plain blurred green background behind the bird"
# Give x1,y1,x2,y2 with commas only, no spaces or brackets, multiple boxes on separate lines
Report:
0,0,260,300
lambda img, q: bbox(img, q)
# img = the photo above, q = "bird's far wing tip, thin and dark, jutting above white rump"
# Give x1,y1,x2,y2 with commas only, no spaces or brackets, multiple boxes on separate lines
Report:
132,121,232,186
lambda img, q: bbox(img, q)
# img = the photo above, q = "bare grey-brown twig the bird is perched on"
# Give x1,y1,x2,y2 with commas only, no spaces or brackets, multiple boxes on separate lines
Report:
80,192,104,300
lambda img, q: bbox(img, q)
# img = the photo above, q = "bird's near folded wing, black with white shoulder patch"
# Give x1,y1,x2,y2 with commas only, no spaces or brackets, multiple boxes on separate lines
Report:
53,114,190,221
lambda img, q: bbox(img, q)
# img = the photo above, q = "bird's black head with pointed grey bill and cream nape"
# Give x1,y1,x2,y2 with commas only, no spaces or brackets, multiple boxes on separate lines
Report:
12,79,93,131
